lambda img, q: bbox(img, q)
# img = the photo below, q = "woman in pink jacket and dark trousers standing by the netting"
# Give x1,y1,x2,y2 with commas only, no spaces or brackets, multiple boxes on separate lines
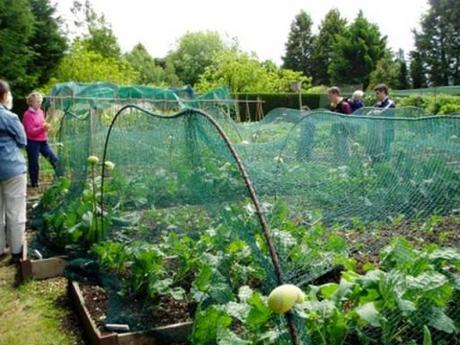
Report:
22,92,59,187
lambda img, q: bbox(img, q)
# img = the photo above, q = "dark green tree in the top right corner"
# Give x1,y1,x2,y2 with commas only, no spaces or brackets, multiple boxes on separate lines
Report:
414,0,460,86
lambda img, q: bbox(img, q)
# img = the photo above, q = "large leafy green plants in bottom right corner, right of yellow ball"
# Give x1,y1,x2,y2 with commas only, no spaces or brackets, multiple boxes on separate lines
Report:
299,239,460,344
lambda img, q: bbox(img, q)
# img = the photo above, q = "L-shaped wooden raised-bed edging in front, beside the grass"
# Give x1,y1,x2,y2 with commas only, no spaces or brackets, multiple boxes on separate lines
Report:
69,281,193,345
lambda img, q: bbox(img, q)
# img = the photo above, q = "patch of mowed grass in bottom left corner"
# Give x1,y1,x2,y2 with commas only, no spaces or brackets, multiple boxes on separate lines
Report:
0,258,85,345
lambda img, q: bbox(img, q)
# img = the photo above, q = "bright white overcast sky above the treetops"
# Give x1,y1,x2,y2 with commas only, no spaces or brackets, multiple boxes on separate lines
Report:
56,0,428,64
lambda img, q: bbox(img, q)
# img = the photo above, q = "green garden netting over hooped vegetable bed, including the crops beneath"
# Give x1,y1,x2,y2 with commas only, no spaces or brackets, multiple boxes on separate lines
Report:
32,85,460,344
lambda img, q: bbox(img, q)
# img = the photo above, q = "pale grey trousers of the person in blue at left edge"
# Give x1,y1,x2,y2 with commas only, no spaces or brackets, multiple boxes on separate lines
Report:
0,174,27,254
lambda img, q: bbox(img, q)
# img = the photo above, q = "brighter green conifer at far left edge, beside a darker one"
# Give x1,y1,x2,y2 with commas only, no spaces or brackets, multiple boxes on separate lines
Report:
0,0,36,95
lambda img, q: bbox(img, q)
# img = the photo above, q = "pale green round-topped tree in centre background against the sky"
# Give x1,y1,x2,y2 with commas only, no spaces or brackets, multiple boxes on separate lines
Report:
168,31,226,85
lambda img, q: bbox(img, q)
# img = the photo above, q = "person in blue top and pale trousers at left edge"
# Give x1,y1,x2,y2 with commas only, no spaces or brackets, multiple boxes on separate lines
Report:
0,80,27,261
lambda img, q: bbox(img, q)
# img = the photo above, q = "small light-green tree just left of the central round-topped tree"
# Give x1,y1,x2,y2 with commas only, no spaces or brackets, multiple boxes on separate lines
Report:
125,43,165,85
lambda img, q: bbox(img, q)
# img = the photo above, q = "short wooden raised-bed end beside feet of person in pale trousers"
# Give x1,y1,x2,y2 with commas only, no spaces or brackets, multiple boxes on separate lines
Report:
20,241,67,281
